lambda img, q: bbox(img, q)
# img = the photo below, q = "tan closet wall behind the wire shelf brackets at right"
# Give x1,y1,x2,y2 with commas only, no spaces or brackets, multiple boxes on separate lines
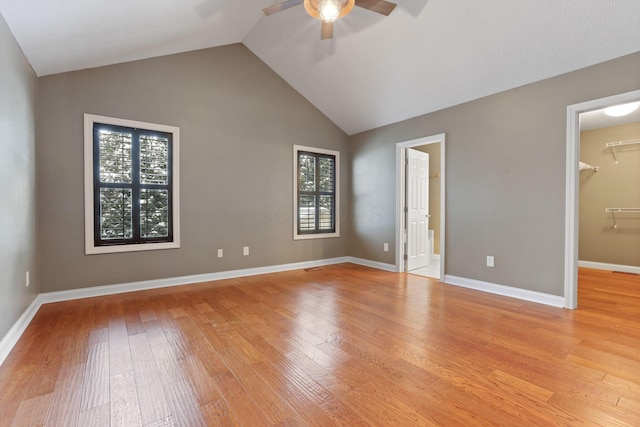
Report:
578,123,640,267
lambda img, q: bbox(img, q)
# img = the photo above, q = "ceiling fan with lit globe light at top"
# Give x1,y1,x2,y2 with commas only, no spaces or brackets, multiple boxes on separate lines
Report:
262,0,396,40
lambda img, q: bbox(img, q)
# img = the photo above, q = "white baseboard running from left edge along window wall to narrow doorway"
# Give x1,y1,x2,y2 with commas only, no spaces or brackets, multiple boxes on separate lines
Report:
0,256,395,365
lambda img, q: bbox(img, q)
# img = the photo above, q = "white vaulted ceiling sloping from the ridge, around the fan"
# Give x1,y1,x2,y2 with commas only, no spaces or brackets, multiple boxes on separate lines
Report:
0,0,640,134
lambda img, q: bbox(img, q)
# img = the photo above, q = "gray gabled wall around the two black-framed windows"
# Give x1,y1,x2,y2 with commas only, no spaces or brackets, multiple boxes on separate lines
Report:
37,44,351,292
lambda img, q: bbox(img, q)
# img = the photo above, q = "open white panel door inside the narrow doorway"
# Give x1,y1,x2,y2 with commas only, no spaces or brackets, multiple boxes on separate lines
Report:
406,148,430,271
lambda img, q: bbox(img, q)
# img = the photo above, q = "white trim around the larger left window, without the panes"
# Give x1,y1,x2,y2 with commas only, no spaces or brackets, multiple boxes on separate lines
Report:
84,114,180,255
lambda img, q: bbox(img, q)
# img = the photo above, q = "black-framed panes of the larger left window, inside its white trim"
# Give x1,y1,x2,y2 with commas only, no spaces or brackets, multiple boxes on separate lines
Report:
94,123,172,245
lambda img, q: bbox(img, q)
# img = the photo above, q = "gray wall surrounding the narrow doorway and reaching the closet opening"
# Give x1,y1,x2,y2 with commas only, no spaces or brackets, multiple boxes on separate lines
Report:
350,53,640,295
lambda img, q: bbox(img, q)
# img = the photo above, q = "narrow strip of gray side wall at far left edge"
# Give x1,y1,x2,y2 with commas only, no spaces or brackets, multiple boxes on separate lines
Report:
0,15,40,339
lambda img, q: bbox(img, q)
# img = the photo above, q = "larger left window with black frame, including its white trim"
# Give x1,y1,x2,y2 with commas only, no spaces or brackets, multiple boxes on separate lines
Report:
85,114,180,254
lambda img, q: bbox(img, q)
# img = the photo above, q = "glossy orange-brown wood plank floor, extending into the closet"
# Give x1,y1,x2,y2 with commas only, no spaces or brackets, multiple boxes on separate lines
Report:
0,264,640,427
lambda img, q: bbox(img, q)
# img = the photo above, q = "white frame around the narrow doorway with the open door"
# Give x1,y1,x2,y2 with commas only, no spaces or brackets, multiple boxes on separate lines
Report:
396,133,446,281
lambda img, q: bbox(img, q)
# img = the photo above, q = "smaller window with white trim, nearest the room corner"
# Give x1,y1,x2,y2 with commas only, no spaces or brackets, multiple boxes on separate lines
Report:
293,145,340,240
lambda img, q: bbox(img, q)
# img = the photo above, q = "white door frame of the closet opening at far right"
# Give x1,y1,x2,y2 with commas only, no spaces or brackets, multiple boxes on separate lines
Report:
564,90,640,309
